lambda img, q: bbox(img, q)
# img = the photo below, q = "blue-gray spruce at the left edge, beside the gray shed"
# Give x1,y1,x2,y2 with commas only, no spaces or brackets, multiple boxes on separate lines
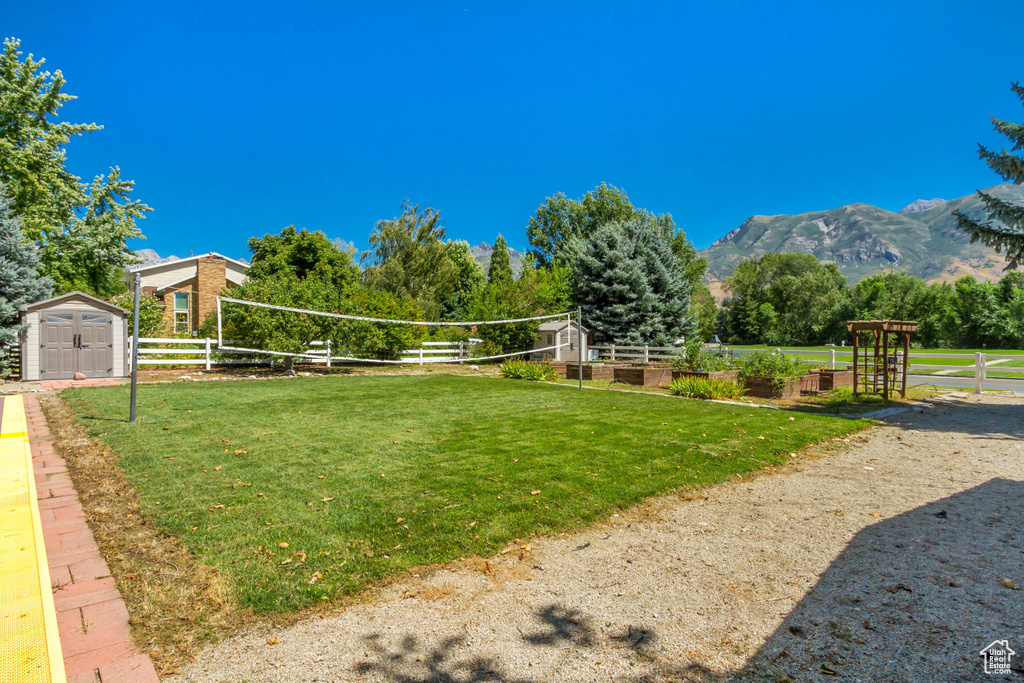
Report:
0,185,52,377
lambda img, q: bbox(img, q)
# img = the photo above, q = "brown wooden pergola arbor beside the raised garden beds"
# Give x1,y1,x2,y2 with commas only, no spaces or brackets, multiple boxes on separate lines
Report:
846,321,918,400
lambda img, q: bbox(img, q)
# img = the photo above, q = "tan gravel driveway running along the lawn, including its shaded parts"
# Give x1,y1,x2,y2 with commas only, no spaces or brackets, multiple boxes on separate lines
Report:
166,395,1024,683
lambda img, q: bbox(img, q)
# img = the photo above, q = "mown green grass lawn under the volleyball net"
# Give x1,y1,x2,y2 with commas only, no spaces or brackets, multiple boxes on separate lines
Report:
62,375,867,612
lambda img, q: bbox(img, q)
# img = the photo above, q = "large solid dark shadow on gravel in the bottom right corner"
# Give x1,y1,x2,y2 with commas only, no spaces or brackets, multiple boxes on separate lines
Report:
729,479,1024,683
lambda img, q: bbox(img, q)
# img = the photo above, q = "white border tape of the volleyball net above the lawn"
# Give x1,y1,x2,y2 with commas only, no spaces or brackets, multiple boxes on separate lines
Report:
217,297,571,365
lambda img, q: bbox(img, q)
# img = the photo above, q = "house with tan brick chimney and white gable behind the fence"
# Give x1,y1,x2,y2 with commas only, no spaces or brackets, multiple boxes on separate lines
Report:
121,252,249,336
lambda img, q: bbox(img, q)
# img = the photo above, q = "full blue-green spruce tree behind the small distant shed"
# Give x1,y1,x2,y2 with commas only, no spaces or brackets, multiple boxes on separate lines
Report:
569,219,696,346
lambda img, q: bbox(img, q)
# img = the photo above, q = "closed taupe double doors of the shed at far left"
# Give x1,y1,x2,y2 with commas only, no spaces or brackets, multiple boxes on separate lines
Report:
39,311,114,380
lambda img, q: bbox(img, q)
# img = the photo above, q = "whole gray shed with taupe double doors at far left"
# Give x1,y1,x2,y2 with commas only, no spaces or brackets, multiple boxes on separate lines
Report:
22,292,129,381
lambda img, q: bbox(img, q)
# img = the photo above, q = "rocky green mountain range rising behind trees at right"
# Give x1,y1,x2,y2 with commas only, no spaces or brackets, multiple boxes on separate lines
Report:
698,183,1024,296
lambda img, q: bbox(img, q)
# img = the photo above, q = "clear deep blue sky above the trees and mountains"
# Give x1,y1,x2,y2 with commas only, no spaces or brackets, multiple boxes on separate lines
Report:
6,0,1024,257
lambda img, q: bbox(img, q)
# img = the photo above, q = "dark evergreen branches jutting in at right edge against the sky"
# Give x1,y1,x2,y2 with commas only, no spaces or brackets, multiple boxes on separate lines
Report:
953,83,1024,268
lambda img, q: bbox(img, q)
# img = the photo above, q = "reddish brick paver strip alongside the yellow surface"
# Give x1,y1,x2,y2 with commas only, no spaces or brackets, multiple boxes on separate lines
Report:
25,396,160,683
